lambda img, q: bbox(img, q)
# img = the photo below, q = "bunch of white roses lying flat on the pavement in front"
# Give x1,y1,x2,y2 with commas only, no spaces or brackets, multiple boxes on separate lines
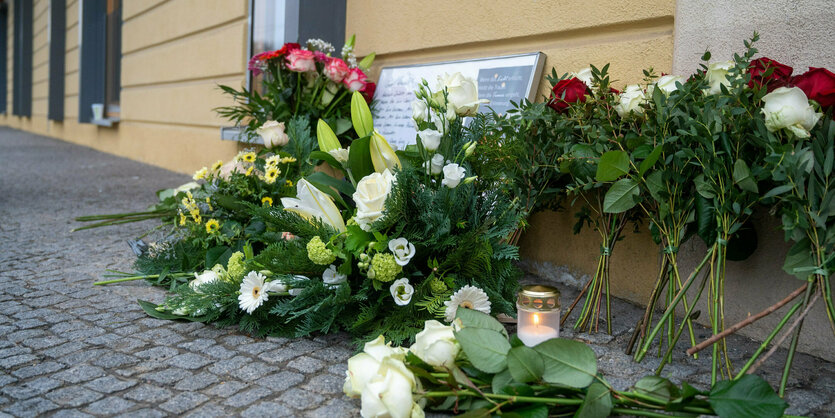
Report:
343,309,788,418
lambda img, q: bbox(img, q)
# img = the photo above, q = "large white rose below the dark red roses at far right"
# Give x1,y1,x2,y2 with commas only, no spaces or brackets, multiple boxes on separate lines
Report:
762,87,823,138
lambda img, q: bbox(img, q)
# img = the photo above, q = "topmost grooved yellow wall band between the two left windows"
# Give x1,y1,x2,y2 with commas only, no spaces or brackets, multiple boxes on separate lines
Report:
122,0,247,54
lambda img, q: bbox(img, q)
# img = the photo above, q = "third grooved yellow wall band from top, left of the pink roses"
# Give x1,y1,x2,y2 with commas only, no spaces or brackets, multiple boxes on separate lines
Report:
120,78,241,126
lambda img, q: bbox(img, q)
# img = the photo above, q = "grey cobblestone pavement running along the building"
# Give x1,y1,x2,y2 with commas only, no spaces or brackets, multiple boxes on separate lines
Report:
0,128,835,417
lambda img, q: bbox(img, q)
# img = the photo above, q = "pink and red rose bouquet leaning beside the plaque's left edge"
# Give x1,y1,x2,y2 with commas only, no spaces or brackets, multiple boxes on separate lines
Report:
217,37,376,148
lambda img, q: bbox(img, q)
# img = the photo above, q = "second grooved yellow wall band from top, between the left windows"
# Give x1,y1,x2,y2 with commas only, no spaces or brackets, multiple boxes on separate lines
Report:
122,21,246,87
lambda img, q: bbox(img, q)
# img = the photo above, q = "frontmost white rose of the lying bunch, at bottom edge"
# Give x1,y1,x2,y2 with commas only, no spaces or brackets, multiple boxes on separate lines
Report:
360,358,420,418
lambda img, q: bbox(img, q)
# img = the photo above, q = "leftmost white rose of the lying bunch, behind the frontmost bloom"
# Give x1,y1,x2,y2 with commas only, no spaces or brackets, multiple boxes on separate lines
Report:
342,335,406,398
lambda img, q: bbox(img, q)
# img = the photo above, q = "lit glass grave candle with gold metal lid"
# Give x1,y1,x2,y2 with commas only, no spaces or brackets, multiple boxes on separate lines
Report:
516,285,560,347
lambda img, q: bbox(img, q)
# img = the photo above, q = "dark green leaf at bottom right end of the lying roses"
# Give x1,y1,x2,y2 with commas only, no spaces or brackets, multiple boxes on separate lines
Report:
708,374,789,418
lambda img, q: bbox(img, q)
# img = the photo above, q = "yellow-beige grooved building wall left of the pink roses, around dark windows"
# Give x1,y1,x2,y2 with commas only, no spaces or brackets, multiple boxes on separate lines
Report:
0,0,248,173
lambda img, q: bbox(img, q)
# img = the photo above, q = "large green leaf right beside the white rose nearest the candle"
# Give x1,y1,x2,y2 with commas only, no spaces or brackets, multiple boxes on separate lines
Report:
455,328,510,373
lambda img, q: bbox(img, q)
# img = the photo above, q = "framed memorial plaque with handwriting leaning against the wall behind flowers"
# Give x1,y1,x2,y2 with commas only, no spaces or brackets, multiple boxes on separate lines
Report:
374,52,545,149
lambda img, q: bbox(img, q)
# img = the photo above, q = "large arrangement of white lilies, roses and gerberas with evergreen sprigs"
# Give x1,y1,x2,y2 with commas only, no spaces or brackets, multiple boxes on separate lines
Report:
143,74,520,341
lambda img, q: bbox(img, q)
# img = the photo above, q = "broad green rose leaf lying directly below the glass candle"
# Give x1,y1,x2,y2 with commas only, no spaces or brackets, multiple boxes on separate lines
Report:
534,339,597,388
